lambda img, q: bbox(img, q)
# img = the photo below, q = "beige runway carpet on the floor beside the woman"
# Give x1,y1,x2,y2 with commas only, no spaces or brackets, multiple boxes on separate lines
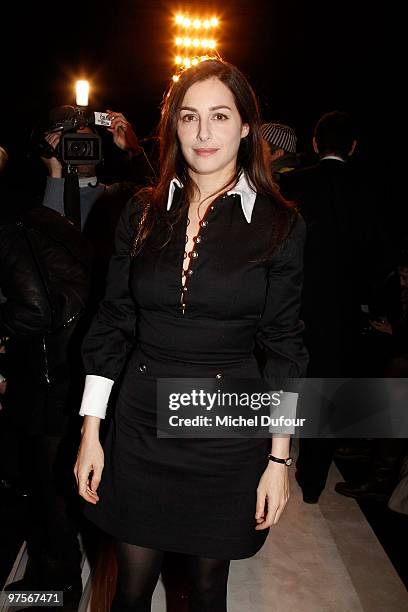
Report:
152,444,408,612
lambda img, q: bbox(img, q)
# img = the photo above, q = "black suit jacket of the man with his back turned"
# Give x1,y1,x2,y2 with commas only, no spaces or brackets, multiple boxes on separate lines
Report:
281,159,387,372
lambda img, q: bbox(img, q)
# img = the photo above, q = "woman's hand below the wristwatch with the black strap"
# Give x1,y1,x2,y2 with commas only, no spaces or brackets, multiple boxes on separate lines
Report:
255,461,289,531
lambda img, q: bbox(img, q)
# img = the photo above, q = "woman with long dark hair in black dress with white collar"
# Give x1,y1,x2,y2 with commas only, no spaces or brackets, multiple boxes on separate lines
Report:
75,60,307,612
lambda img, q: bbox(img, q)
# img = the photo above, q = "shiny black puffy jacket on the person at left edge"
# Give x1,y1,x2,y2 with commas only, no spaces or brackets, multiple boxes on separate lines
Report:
0,207,91,382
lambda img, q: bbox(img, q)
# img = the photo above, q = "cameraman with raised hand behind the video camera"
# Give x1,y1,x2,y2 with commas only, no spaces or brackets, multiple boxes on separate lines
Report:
41,106,155,313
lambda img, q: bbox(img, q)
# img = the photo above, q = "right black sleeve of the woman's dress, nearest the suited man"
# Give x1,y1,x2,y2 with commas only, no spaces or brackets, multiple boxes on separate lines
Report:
256,215,308,379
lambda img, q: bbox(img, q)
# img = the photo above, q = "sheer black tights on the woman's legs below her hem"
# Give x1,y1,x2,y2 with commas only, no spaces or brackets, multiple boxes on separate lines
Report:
111,542,230,612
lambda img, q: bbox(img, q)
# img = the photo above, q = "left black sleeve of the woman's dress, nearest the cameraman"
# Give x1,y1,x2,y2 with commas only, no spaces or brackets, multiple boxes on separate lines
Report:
82,200,137,380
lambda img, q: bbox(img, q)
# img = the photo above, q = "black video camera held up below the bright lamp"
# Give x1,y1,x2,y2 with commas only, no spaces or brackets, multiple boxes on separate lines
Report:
36,106,102,166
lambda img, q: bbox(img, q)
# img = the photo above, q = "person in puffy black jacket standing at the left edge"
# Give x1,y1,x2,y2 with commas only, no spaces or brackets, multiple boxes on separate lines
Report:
0,143,91,610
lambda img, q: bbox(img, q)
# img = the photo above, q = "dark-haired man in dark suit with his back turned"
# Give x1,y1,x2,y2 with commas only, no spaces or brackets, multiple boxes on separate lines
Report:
281,111,384,503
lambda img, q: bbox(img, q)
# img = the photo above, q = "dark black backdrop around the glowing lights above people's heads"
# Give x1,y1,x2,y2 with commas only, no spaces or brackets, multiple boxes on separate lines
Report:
0,0,389,175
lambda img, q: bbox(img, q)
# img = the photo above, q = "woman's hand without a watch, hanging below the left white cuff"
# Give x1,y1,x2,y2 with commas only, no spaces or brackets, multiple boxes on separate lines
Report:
74,432,104,504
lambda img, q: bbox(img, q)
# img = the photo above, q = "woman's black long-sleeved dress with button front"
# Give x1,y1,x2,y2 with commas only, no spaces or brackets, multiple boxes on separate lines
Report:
83,190,307,559
